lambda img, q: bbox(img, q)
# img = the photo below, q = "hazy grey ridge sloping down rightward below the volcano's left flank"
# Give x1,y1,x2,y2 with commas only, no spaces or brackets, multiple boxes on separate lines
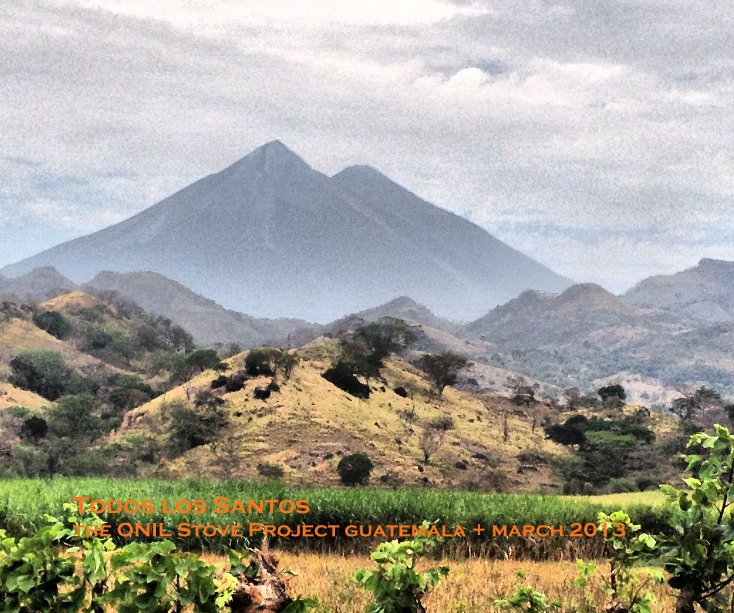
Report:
84,271,317,347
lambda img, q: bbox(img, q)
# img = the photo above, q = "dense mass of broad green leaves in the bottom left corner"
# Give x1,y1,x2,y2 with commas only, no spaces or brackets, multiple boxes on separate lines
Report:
0,506,227,613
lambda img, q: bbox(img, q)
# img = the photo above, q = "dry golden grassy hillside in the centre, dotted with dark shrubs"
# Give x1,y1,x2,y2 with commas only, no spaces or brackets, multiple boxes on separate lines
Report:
117,343,568,491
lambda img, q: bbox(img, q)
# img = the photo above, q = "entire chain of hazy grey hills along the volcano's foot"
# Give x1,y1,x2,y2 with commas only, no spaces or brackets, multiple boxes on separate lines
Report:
0,255,734,396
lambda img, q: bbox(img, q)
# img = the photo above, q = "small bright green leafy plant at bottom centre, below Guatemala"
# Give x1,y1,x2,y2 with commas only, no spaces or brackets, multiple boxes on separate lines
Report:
354,521,449,613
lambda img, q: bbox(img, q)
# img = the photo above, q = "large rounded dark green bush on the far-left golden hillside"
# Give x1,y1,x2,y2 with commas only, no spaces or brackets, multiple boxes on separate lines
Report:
10,350,86,400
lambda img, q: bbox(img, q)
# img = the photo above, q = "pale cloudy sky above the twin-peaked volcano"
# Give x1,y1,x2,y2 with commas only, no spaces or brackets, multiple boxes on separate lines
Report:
0,0,734,292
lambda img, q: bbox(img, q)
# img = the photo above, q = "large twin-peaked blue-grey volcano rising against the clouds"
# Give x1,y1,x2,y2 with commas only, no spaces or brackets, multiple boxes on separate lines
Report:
0,141,570,321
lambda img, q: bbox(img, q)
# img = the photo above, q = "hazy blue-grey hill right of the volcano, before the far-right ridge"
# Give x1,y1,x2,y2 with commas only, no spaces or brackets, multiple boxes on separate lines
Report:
465,284,734,390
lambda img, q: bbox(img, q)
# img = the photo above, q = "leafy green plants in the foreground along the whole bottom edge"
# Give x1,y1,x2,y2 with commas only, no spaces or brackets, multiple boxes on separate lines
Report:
0,425,734,613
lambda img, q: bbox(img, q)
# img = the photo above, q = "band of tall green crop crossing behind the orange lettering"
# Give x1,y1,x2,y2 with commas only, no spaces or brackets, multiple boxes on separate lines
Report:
0,478,663,560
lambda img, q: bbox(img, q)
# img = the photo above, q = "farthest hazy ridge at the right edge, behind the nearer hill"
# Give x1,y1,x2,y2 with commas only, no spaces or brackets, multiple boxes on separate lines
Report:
624,259,734,322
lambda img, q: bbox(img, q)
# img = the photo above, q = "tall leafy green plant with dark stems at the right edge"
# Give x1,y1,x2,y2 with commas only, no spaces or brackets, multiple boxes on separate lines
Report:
659,424,734,613
